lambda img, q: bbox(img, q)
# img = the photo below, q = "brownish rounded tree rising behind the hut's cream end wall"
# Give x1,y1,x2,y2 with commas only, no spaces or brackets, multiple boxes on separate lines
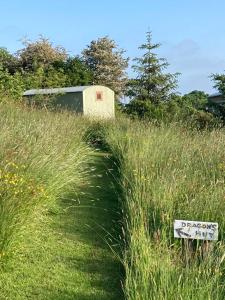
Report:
82,37,128,98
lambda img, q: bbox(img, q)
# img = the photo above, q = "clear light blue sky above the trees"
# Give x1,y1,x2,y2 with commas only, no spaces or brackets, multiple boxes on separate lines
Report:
0,0,225,94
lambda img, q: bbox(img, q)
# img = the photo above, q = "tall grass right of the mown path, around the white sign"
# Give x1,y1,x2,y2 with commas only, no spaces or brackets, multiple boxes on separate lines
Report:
106,120,225,300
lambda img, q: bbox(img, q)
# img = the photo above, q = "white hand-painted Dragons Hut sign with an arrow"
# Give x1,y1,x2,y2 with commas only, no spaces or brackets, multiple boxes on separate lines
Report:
174,220,218,241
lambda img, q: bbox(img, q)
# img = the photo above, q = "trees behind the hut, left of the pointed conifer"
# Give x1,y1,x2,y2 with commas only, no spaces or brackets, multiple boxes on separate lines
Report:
0,36,128,99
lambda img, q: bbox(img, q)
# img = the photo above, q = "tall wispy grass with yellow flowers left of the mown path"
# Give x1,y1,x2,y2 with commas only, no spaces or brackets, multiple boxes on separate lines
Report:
0,104,90,257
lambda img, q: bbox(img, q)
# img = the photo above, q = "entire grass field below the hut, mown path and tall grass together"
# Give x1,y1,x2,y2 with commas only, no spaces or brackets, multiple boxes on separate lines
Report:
0,102,225,300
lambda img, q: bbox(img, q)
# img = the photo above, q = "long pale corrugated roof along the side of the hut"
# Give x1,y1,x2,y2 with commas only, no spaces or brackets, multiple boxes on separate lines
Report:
23,86,91,96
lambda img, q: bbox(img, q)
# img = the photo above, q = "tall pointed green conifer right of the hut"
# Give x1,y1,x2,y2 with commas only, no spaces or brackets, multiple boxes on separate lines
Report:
127,32,178,104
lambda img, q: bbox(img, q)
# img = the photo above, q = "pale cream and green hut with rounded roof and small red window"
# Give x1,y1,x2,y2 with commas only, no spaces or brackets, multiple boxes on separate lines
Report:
23,85,115,118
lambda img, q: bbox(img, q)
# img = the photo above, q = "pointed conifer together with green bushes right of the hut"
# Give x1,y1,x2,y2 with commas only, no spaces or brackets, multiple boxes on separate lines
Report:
125,32,225,128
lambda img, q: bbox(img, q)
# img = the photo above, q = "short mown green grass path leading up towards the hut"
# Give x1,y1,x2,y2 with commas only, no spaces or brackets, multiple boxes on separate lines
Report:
0,154,123,300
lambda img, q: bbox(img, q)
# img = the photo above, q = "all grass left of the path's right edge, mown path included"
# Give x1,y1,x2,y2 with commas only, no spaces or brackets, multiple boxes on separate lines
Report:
0,105,123,300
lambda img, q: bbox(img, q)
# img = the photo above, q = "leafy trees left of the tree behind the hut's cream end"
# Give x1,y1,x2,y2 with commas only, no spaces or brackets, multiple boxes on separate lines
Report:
0,37,92,99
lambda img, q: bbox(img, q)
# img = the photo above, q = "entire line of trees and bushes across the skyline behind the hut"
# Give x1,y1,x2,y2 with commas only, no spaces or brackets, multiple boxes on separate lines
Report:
0,32,225,127
